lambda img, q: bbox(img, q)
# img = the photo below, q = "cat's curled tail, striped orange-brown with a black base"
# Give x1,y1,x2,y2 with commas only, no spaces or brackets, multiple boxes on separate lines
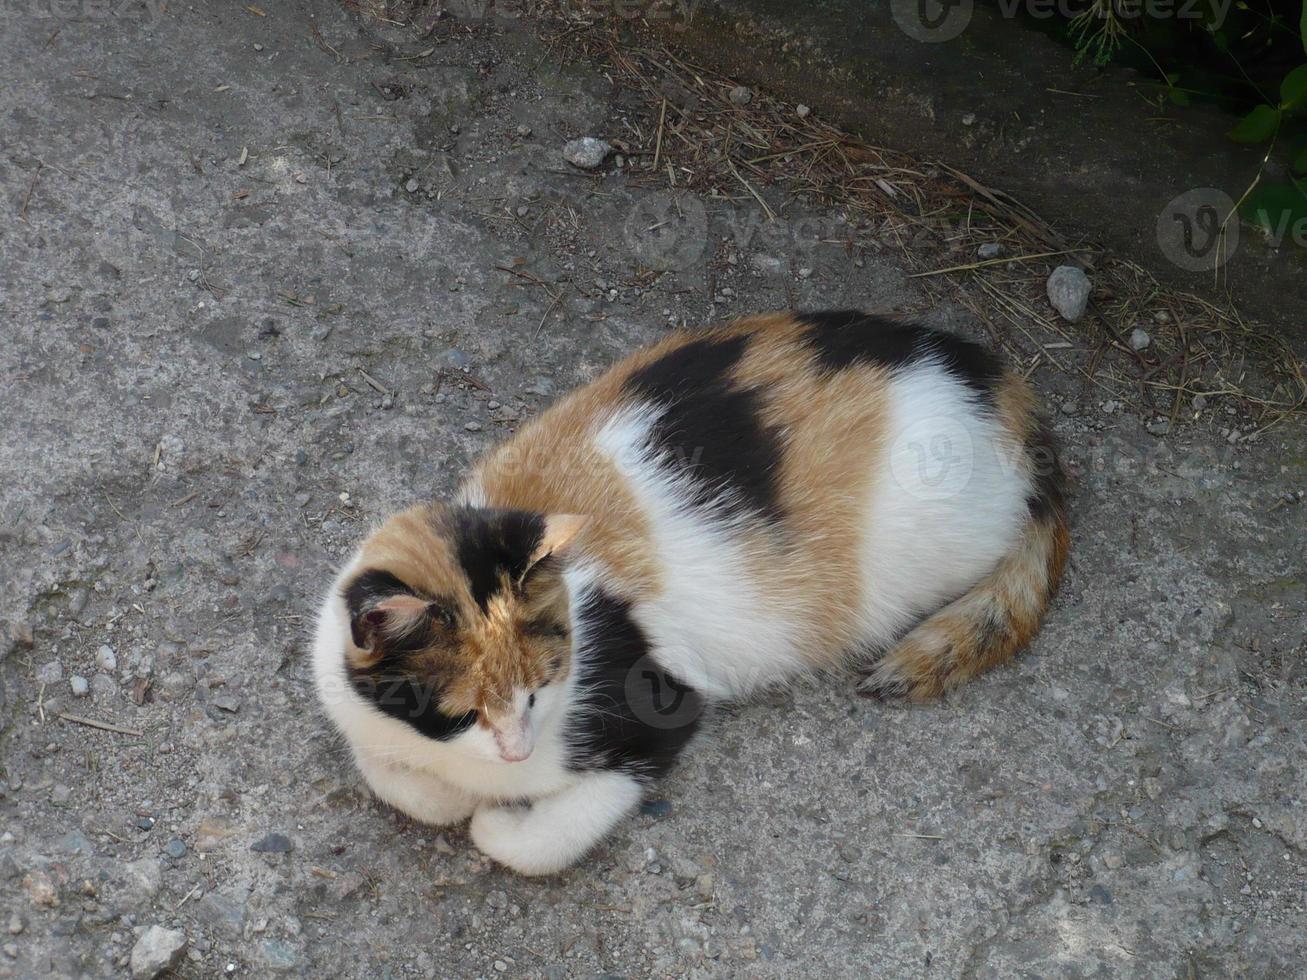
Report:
859,402,1070,700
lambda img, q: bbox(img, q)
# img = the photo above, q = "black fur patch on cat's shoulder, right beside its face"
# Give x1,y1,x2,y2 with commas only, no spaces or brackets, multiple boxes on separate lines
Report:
569,589,704,776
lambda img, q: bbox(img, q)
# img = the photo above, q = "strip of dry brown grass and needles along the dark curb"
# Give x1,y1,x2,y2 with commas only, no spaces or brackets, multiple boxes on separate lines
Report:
358,0,1307,431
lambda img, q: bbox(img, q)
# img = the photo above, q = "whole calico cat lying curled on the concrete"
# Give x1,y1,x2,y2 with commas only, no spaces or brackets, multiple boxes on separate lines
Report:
314,312,1069,874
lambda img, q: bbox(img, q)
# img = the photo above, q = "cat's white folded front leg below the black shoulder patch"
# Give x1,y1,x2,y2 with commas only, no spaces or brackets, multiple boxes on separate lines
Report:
472,772,643,874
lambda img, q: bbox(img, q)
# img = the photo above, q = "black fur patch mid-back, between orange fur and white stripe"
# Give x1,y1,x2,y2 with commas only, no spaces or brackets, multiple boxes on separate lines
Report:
626,337,780,517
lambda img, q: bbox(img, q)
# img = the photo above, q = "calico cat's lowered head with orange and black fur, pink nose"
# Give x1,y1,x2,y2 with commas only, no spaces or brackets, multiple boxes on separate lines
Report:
342,504,586,762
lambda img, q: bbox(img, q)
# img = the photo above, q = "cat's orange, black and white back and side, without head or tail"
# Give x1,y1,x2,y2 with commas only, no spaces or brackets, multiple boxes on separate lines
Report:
467,312,1029,693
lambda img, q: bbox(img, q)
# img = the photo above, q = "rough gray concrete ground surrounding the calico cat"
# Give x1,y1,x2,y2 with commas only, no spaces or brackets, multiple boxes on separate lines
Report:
0,3,1307,977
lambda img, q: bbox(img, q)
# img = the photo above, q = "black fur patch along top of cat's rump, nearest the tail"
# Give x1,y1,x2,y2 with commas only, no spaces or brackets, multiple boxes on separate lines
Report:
797,310,1002,397
